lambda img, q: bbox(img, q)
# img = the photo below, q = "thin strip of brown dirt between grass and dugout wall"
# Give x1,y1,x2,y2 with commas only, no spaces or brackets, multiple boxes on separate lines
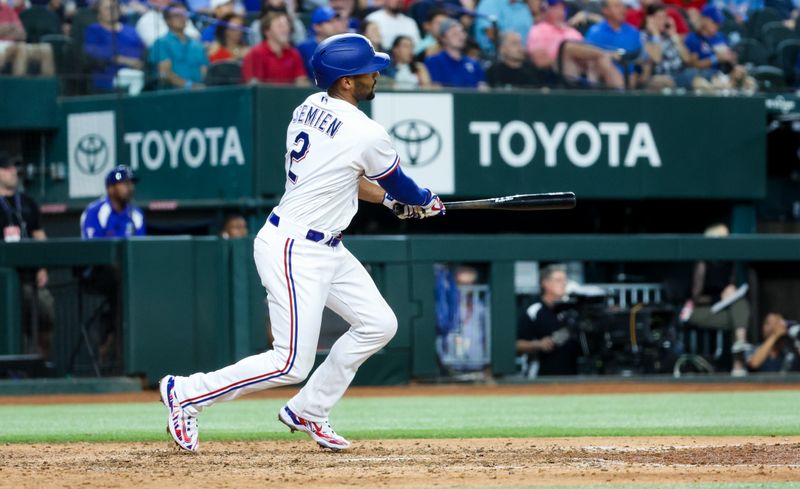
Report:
0,381,800,405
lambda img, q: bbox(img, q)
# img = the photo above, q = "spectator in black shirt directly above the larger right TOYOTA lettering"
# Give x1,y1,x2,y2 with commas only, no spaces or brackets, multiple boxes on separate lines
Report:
486,31,548,88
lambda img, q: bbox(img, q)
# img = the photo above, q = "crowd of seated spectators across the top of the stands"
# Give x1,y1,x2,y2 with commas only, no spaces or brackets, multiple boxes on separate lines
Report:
0,0,800,94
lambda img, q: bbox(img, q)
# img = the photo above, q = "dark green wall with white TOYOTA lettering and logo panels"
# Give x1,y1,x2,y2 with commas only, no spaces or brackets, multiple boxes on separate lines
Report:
15,86,768,208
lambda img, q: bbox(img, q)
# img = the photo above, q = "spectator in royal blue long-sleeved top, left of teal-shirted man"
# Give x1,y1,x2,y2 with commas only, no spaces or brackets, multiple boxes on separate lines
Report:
83,0,145,95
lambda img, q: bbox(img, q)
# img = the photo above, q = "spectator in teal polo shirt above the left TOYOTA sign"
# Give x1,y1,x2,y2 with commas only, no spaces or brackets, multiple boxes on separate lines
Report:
149,2,208,90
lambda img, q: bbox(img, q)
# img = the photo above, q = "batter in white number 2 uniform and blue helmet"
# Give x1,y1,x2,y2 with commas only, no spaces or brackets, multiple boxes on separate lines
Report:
159,34,445,452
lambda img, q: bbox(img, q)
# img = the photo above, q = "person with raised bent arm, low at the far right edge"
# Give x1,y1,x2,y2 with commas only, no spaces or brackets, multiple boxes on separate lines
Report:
746,314,800,372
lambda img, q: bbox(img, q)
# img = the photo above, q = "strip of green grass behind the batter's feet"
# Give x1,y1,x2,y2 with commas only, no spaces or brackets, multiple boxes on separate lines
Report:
0,391,800,443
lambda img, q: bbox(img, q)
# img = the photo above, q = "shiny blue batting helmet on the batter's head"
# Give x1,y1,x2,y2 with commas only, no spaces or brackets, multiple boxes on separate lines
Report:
311,34,389,90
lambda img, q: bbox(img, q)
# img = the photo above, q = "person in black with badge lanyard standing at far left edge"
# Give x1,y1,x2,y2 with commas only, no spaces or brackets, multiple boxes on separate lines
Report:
0,152,55,358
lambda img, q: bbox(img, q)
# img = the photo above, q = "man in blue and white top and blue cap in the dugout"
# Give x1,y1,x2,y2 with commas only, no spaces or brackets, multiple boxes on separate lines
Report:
81,165,145,239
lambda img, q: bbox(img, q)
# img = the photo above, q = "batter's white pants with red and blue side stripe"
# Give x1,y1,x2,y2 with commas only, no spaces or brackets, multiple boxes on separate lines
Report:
175,221,397,422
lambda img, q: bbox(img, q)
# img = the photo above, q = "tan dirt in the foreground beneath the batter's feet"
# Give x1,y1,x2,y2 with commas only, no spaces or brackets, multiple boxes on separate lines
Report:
0,437,800,489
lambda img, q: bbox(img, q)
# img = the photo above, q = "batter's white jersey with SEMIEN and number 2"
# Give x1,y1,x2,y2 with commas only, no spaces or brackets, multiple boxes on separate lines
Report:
275,92,400,235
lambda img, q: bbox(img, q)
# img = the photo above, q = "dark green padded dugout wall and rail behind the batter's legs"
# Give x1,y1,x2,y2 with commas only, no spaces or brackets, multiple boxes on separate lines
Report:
0,235,800,384
